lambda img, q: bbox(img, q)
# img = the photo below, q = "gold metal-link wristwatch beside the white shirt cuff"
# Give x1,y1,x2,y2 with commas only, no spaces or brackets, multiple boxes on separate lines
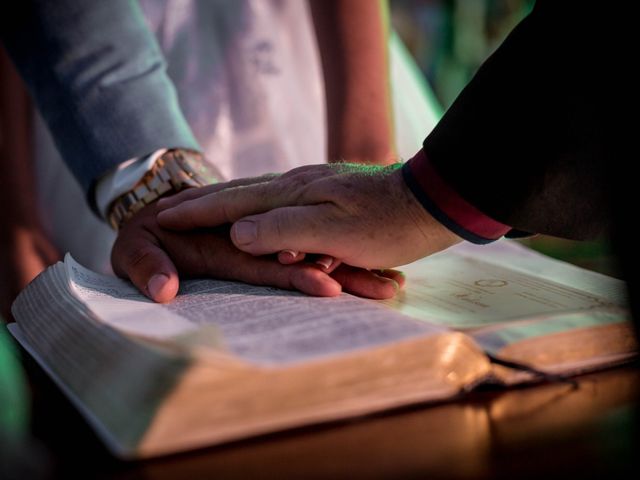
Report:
107,149,219,230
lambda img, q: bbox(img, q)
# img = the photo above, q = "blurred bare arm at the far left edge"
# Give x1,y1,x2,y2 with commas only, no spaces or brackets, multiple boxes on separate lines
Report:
0,48,60,320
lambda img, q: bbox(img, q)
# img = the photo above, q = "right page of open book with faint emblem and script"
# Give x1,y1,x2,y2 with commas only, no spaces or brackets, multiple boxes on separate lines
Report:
384,242,624,328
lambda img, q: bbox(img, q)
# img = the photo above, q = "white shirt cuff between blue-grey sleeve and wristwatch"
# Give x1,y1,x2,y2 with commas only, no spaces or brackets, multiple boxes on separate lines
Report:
96,148,167,219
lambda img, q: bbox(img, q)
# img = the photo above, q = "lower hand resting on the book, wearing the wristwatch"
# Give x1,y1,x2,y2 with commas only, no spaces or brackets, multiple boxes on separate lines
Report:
111,197,402,302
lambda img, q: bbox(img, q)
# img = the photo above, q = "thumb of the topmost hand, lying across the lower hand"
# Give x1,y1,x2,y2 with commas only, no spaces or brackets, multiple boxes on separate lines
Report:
231,204,340,258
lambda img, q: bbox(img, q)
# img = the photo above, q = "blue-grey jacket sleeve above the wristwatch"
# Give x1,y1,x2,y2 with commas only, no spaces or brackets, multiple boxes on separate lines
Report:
0,0,199,192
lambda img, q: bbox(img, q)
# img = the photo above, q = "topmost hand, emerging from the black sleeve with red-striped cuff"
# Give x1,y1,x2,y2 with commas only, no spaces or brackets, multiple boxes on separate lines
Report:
158,164,461,269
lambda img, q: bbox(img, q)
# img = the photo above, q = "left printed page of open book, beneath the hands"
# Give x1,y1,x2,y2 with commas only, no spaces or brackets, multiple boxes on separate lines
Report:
65,256,447,365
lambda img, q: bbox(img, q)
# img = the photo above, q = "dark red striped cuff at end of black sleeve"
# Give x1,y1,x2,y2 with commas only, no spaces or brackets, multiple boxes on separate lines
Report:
402,150,511,244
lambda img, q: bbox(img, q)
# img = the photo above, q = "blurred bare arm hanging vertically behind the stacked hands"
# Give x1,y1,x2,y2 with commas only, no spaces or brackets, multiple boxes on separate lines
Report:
310,0,396,165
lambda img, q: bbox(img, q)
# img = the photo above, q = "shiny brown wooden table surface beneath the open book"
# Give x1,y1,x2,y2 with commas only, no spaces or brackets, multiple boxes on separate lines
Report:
6,360,640,479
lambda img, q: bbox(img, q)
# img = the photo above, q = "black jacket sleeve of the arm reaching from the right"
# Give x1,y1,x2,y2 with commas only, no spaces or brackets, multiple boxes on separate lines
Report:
424,0,616,239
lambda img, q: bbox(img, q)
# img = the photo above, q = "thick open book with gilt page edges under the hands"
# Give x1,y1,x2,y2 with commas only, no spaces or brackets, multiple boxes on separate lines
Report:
9,241,637,458
